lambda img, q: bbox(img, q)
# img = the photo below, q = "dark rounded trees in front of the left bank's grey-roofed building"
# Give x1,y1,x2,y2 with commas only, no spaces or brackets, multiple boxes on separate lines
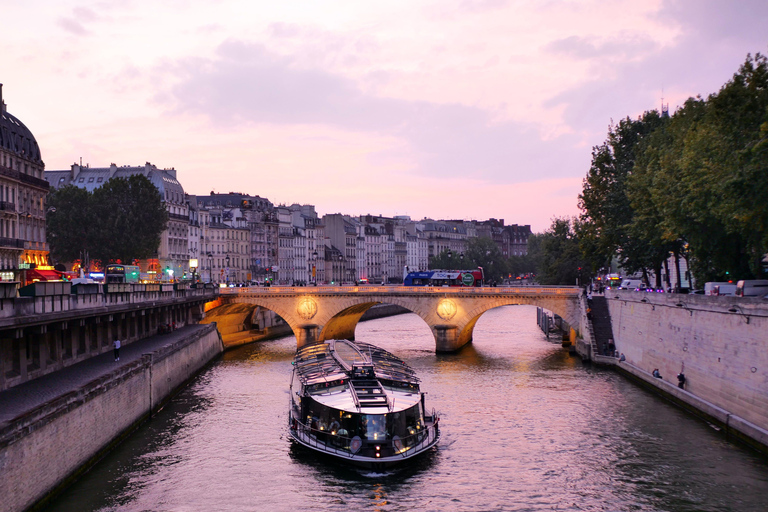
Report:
47,175,168,264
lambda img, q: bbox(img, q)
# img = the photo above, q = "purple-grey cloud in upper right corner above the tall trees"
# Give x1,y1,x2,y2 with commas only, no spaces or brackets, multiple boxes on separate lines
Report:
544,0,768,140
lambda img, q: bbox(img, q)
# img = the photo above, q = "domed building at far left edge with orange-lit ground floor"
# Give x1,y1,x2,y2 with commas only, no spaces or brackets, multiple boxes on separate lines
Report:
0,84,49,281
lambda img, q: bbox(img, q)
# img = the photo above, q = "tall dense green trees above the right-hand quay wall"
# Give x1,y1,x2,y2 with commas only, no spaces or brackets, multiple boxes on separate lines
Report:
575,54,768,286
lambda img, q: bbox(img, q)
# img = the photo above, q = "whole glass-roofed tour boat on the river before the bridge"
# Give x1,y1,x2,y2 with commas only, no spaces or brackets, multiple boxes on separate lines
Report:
288,340,440,469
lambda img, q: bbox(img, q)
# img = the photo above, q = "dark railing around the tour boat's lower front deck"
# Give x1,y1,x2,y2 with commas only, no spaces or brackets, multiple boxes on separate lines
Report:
293,411,440,458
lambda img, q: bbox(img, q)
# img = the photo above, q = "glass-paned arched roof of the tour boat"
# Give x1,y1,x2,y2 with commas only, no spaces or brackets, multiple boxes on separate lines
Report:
294,340,419,386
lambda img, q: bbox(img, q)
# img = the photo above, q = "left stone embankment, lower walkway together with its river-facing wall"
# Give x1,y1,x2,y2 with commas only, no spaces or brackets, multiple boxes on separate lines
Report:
0,325,224,512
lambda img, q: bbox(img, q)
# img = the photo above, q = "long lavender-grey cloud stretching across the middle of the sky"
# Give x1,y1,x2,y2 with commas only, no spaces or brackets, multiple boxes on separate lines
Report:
164,41,582,183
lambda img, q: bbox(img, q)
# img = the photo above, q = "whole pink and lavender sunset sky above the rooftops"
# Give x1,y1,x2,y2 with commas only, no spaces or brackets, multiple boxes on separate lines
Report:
0,0,768,232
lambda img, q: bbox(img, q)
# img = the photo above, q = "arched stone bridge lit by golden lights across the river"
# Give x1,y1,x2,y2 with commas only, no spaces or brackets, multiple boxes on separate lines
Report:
217,285,581,352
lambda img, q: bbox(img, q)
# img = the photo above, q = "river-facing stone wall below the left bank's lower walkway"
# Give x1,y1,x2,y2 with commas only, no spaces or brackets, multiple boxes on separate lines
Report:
0,325,223,512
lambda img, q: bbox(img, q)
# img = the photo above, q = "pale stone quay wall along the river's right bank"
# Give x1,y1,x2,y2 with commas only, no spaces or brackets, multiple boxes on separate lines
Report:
594,290,768,454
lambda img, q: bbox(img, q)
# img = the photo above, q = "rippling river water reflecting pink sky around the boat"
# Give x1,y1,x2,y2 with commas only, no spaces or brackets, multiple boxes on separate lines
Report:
51,306,768,512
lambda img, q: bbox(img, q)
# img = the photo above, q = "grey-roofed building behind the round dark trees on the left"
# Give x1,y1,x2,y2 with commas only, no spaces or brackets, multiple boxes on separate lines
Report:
45,162,189,280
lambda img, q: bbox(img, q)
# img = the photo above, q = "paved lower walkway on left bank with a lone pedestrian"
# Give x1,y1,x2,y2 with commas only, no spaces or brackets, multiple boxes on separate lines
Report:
0,325,208,427
